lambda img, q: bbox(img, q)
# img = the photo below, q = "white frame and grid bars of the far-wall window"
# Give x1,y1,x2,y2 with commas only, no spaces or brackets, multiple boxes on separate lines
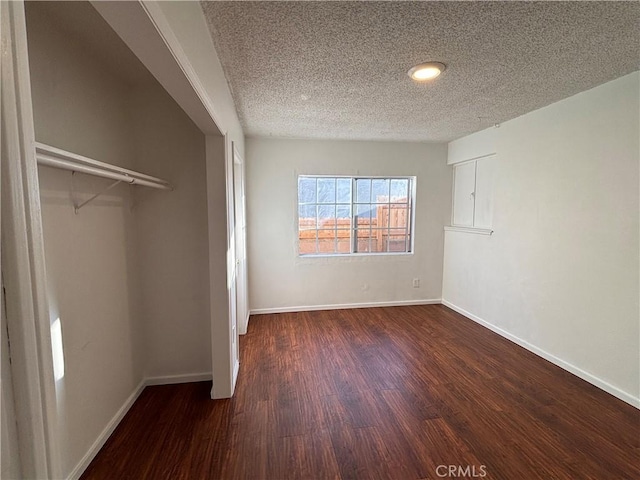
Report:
296,174,417,258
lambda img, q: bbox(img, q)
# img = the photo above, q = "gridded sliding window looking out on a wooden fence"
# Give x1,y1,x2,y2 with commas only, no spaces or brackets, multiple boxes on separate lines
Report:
298,175,415,255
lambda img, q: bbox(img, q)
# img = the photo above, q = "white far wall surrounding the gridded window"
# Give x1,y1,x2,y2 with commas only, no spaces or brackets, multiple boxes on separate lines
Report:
246,138,451,312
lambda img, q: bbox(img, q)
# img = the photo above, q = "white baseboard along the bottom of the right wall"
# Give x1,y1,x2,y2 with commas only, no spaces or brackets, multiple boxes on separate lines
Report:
442,299,640,408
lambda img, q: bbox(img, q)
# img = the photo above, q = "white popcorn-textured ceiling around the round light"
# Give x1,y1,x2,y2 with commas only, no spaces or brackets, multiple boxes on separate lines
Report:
202,1,640,141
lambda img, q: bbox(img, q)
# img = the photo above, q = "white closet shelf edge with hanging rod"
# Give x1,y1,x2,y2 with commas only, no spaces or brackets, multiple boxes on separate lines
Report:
36,142,173,190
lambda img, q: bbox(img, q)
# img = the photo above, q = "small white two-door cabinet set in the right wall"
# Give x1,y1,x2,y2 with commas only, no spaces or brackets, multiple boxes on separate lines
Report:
451,155,496,233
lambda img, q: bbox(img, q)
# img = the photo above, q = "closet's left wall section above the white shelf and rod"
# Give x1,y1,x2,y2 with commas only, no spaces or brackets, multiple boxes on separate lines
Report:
25,2,133,167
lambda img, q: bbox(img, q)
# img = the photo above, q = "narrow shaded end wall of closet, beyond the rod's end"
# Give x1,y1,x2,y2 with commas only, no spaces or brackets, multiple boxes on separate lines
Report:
130,83,211,377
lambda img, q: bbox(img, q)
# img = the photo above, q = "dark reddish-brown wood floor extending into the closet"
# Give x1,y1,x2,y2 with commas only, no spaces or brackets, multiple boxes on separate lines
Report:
83,305,640,480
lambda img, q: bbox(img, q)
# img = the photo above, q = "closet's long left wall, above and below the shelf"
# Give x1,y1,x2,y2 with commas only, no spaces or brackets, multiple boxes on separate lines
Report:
27,5,143,474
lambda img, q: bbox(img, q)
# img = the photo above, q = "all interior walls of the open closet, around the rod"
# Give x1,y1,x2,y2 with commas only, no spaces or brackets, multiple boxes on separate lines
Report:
25,2,211,476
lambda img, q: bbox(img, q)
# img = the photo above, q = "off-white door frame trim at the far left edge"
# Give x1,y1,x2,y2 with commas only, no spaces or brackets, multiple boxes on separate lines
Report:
0,0,62,478
